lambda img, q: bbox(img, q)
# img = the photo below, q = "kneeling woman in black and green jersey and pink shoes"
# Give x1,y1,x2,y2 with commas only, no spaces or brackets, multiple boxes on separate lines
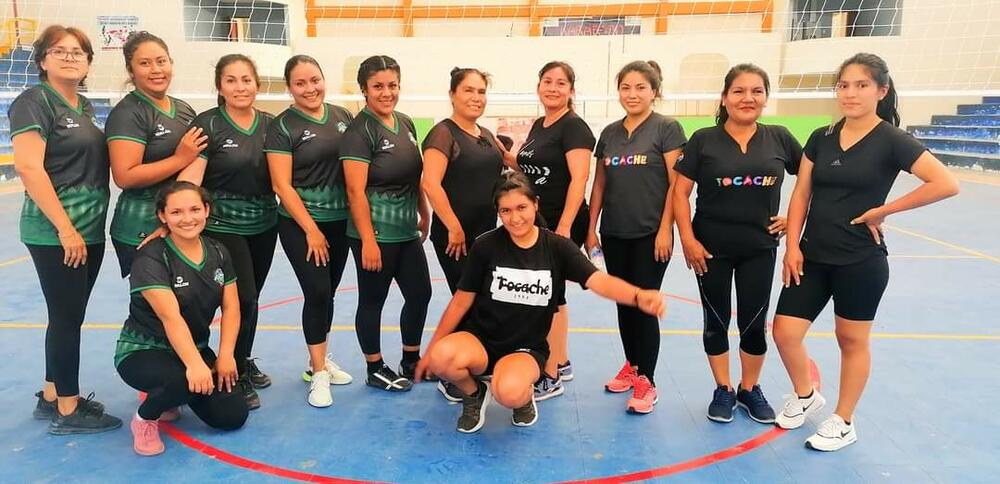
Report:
115,182,249,455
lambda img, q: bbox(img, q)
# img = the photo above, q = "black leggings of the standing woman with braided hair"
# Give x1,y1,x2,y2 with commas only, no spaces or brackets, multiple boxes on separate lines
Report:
347,238,431,355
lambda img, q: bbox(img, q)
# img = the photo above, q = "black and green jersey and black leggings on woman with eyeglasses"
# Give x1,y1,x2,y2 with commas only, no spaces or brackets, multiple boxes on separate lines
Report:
7,82,110,397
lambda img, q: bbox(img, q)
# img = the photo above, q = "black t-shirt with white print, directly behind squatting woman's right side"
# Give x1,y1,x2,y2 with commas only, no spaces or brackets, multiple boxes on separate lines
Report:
517,111,594,217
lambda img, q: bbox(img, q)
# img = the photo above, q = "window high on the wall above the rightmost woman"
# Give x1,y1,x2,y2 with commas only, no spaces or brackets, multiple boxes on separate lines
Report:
789,0,903,40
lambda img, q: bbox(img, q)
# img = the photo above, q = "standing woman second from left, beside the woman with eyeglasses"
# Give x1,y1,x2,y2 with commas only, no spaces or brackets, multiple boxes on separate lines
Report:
104,31,207,277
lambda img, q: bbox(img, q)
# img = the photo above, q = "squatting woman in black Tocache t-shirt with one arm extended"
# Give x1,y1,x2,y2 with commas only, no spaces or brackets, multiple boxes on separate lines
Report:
416,172,665,433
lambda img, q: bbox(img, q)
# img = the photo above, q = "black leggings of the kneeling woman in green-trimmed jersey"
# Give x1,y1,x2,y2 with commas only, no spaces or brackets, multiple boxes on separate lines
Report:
118,348,249,430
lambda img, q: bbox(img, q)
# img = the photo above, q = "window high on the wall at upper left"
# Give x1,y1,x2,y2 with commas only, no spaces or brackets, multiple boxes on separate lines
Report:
184,0,288,45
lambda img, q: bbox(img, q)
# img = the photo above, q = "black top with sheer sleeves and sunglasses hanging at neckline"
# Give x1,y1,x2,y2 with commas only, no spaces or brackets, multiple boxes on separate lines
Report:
424,119,503,246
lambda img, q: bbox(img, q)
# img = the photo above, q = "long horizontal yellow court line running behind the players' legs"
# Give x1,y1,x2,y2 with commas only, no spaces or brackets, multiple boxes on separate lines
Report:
0,322,1000,341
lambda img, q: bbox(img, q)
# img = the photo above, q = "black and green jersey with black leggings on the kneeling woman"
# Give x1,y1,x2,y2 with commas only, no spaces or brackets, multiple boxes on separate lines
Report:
115,237,248,428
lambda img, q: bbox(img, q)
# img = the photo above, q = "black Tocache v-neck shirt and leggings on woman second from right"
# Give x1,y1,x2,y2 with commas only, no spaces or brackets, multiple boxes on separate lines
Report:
675,124,802,356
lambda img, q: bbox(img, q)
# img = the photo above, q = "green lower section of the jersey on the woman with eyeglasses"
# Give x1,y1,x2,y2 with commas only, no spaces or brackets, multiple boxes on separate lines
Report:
20,185,111,246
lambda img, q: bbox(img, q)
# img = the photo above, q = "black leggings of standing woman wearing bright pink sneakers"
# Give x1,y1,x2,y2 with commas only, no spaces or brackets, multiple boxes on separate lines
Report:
601,233,667,380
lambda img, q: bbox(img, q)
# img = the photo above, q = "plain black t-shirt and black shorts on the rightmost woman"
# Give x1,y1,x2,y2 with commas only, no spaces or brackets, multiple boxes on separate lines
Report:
777,120,927,321
